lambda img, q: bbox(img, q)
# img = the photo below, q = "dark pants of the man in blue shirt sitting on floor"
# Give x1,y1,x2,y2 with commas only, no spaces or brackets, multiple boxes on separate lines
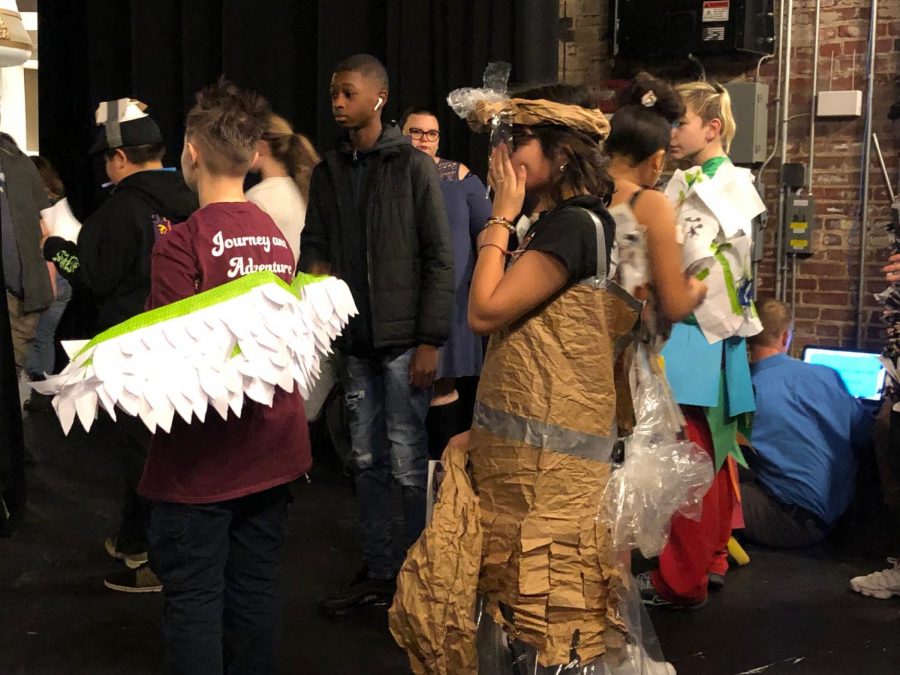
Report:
741,470,828,548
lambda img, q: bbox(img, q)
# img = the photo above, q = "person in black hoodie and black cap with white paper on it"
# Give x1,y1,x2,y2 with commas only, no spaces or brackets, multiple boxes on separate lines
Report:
44,99,199,593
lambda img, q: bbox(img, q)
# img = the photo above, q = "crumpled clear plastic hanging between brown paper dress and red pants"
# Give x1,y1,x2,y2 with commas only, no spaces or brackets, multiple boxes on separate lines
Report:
603,344,714,558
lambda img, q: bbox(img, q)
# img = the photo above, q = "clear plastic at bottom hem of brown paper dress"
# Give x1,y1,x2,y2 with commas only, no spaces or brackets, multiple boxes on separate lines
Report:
476,573,675,675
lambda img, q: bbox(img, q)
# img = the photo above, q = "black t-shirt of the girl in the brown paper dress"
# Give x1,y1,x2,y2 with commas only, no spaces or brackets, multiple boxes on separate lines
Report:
524,196,616,283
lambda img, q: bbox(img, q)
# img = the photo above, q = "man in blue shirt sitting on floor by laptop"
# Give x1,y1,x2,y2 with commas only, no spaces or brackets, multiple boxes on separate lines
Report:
741,299,873,548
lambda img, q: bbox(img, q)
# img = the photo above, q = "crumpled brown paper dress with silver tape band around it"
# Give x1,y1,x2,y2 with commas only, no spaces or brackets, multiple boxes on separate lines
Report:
391,258,639,674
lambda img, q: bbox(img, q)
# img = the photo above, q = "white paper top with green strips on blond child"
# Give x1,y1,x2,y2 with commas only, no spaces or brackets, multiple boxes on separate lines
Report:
666,162,766,344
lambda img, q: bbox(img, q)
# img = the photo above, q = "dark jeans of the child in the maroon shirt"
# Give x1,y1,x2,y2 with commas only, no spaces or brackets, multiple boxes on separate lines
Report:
149,485,289,675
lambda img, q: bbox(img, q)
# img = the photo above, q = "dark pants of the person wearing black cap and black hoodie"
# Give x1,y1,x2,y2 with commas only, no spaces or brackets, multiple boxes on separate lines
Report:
111,411,150,554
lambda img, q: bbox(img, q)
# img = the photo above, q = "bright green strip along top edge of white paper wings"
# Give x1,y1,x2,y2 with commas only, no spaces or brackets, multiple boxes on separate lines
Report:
75,270,326,365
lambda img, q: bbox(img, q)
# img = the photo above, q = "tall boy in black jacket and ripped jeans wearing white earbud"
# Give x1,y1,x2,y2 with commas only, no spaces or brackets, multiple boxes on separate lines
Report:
300,54,454,615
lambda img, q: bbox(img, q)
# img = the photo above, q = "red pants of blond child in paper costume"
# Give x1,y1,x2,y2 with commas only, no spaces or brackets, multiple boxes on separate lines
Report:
651,409,737,604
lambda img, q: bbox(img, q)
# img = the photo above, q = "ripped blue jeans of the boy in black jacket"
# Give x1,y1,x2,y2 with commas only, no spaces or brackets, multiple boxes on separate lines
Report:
342,349,431,579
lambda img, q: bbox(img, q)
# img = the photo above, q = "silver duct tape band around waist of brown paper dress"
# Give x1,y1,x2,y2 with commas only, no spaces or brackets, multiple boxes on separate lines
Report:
472,402,619,462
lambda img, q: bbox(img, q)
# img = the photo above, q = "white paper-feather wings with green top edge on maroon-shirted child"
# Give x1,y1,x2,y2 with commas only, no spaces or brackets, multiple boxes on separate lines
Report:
32,271,357,434
